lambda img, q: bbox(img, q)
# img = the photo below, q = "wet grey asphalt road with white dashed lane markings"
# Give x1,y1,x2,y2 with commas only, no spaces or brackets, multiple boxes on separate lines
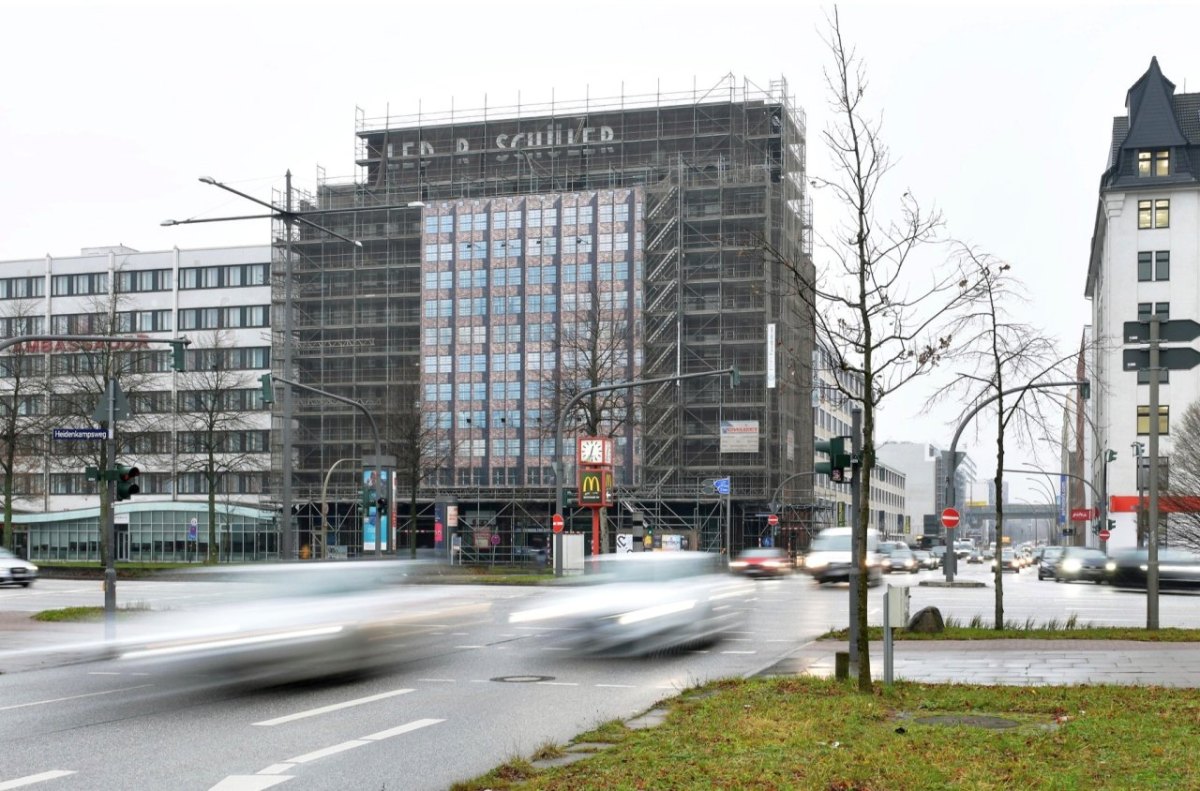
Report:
0,568,1200,791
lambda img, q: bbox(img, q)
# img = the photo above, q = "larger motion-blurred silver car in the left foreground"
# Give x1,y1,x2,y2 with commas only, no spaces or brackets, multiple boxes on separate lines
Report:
106,562,486,683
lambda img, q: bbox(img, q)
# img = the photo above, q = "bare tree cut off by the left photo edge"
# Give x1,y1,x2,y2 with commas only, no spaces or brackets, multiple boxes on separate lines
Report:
0,300,48,550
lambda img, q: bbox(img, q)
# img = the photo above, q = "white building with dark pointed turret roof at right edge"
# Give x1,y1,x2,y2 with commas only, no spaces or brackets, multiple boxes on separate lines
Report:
1080,59,1200,547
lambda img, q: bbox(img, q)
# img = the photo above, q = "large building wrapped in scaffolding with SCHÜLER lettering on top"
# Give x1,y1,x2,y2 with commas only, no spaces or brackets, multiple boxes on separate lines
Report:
272,77,814,557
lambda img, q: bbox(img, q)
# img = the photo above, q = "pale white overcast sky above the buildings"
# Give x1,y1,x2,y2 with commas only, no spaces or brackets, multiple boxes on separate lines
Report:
0,0,1200,499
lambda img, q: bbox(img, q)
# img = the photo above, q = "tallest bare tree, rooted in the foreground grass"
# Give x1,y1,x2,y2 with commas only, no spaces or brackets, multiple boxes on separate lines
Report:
767,8,976,691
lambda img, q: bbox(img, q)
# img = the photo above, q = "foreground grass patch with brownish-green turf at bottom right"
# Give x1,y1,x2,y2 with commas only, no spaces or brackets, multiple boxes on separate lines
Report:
454,677,1200,791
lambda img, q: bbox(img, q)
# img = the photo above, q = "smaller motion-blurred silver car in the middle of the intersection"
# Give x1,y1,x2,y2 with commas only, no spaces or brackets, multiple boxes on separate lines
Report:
509,552,755,657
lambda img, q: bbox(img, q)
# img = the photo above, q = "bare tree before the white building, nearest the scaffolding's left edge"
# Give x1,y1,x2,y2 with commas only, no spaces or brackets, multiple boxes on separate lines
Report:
175,331,269,563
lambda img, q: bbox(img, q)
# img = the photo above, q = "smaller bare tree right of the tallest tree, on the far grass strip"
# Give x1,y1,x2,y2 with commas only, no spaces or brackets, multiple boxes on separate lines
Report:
928,245,1066,629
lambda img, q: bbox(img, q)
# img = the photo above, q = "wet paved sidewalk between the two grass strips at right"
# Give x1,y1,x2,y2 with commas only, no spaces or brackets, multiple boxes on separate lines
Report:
760,640,1200,687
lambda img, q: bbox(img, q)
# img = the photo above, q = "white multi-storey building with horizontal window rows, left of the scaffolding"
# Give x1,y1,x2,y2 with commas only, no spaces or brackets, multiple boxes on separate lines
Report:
0,246,278,561
